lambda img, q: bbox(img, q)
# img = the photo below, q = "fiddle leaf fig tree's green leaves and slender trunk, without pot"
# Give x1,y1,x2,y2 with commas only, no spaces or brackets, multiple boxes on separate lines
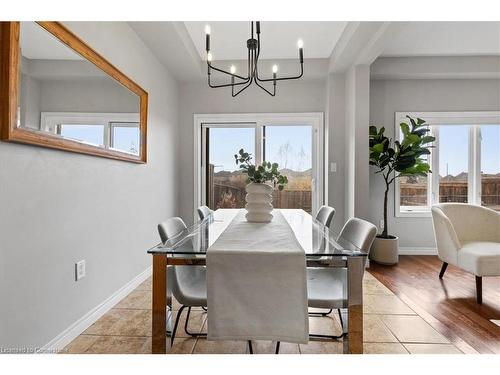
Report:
370,116,435,238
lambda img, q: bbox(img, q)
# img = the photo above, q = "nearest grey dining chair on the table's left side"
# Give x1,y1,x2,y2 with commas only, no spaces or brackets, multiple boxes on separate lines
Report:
158,217,207,344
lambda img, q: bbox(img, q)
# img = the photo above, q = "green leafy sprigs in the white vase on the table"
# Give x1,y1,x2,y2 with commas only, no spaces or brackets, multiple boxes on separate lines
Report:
234,149,288,190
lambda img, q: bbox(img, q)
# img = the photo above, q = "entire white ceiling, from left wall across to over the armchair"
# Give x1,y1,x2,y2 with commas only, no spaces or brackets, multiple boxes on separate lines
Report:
129,21,500,82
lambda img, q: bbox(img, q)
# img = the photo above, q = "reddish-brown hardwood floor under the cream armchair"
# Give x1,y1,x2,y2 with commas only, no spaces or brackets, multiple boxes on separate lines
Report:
369,256,500,354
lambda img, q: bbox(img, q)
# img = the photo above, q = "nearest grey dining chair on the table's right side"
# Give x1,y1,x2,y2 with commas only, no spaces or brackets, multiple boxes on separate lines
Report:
307,218,377,339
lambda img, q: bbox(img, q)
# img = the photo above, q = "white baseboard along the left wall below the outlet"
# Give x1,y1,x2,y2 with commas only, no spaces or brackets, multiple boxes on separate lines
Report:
38,267,152,353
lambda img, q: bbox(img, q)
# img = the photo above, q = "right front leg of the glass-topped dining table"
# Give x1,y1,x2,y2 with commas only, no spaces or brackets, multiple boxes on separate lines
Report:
343,257,365,354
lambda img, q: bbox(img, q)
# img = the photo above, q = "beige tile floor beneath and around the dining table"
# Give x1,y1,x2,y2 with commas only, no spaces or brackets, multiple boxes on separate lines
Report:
62,272,461,354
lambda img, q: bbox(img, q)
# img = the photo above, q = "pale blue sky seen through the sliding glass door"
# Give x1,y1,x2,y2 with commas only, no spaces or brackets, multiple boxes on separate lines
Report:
209,126,312,172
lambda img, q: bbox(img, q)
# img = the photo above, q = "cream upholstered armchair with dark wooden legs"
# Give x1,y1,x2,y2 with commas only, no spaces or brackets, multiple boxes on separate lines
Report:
432,203,500,303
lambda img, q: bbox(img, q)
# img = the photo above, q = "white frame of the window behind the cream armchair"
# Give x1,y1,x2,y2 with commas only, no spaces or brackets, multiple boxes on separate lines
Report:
394,111,500,217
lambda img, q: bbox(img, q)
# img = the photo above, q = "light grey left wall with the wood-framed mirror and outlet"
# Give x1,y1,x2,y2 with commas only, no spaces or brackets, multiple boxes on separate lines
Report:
0,22,178,347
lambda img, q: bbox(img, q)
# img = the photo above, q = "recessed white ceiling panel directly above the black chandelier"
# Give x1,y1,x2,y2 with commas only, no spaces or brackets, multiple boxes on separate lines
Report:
185,21,347,60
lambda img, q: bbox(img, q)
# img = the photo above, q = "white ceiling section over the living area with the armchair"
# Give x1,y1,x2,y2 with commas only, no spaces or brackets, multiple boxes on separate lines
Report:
382,22,500,56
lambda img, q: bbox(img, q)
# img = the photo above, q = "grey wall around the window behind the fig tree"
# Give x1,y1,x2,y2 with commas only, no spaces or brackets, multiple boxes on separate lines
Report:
370,79,500,248
